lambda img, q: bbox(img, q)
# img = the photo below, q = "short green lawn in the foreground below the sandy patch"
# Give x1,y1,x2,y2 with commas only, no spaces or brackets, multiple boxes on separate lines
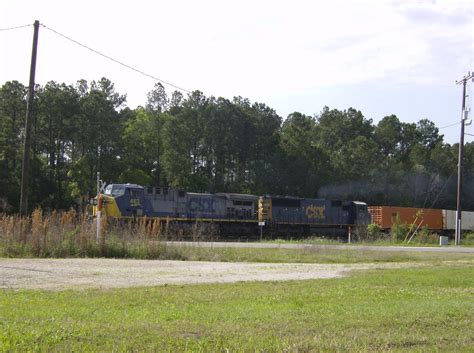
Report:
0,261,474,352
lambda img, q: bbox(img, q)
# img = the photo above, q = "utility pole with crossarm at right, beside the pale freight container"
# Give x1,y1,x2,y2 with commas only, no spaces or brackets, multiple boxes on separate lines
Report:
454,72,473,245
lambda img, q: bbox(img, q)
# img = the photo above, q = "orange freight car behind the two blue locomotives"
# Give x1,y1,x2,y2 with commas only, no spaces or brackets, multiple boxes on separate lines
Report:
369,206,443,230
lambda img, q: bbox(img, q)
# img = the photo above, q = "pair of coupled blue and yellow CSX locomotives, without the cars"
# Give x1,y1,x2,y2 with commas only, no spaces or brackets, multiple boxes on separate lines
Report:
93,184,370,237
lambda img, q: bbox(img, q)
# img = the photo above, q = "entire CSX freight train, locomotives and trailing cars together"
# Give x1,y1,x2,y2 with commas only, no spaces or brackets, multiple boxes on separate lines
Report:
93,184,474,238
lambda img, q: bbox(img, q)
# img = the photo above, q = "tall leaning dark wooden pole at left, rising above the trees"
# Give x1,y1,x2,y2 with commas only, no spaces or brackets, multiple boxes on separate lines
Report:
20,20,39,216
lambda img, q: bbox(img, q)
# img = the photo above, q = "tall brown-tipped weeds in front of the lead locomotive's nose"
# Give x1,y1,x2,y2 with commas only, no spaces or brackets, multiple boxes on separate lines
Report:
0,209,215,259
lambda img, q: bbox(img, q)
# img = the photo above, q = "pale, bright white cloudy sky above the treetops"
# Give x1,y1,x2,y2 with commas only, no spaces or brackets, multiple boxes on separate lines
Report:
0,0,474,143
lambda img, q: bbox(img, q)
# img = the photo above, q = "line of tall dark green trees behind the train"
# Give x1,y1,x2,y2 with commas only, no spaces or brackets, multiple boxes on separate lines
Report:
0,78,474,212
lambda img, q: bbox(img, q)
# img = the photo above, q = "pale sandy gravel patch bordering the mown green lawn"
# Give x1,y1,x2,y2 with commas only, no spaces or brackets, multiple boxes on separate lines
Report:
0,259,413,290
